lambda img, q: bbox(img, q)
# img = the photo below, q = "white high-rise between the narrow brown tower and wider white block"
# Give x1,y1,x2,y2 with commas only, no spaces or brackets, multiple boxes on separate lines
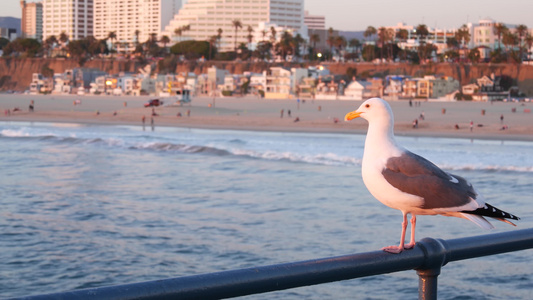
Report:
43,0,93,40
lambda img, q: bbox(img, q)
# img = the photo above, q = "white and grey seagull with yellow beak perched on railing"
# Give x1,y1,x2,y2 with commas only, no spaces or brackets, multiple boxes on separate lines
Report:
344,98,520,253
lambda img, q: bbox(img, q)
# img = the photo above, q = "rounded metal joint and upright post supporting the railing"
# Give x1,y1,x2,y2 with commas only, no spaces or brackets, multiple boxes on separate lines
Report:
416,238,449,300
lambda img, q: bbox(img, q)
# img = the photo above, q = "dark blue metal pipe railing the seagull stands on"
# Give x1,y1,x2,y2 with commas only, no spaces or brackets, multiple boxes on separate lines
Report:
12,228,533,300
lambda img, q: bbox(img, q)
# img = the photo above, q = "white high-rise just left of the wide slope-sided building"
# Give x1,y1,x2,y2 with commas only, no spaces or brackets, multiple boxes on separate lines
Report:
93,0,181,47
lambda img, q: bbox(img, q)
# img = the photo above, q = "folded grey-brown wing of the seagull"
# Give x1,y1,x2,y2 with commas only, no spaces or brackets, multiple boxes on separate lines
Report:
382,151,477,209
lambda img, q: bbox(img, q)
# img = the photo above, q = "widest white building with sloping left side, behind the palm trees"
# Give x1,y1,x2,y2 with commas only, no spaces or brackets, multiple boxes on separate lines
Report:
162,0,307,51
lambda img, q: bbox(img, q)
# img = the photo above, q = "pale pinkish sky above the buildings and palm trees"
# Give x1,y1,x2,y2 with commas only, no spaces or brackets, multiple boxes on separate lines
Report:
4,0,533,31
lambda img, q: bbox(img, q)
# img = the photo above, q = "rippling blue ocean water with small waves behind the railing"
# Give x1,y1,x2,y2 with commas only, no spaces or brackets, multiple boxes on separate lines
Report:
0,122,533,299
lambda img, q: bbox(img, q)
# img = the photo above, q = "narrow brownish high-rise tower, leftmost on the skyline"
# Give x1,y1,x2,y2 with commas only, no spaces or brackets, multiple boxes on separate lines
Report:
20,0,43,41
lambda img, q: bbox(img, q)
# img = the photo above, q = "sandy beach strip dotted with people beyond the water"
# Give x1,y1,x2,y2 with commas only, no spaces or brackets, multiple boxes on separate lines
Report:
0,94,533,141
